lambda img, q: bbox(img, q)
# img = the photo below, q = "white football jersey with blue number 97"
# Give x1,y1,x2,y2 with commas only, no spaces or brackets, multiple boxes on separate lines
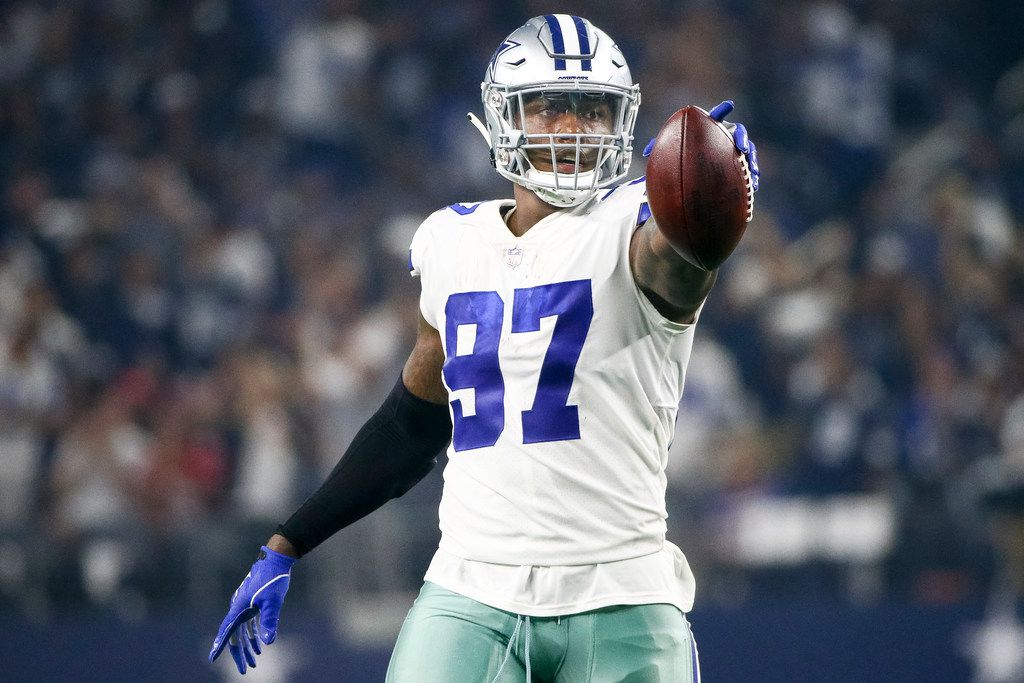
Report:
410,179,693,571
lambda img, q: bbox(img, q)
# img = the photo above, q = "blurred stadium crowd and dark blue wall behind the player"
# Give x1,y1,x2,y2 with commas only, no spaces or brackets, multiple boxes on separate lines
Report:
0,0,1024,682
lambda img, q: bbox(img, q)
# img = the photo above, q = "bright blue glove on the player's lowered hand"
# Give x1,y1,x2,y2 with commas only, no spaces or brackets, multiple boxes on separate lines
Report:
210,546,296,674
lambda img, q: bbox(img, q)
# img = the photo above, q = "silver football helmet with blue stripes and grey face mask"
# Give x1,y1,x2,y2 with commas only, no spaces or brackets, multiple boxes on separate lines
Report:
469,14,640,207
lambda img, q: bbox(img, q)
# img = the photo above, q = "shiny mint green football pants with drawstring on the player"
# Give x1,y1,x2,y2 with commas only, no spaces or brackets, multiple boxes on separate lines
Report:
387,583,700,683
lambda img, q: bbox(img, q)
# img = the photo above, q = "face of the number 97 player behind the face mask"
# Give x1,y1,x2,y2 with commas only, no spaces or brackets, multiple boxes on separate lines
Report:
522,92,614,173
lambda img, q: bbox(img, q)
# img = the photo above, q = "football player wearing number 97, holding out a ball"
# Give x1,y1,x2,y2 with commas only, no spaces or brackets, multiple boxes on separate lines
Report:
210,14,757,683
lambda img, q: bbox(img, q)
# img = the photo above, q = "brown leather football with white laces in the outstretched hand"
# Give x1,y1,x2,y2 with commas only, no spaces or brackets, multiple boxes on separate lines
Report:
647,105,754,270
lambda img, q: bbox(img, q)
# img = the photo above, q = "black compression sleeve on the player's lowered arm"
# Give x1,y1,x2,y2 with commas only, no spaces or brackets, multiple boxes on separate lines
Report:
278,379,452,557
